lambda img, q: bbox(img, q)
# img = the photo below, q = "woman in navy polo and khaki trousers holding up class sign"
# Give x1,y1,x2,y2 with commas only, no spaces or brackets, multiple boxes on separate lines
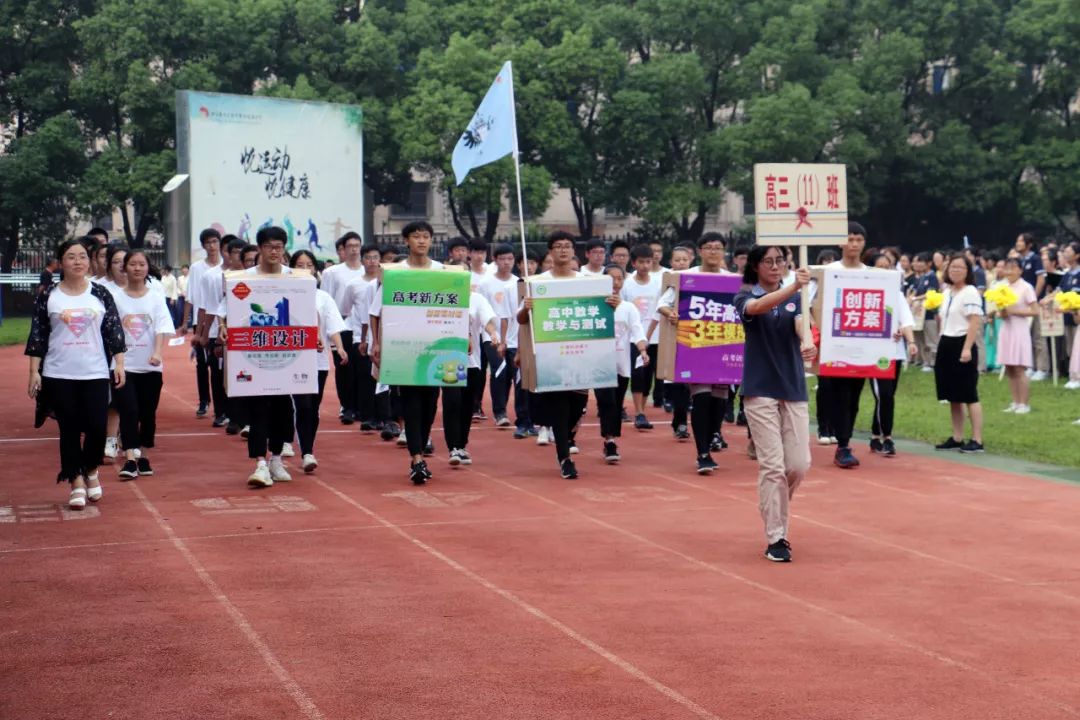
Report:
734,245,816,562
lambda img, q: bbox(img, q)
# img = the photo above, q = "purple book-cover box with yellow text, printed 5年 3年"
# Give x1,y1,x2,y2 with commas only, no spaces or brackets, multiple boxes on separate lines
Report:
657,272,746,384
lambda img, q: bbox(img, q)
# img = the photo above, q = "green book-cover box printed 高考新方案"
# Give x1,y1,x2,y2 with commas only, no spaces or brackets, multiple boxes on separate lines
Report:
378,266,470,388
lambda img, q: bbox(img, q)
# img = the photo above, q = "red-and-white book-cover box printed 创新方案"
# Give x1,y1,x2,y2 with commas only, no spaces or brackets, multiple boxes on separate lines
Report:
812,268,903,378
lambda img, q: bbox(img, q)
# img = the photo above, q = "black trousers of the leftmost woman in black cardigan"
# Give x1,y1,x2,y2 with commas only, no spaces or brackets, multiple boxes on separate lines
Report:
41,378,109,483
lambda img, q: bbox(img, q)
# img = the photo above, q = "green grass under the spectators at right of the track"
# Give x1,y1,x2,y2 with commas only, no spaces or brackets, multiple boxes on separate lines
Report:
808,368,1080,467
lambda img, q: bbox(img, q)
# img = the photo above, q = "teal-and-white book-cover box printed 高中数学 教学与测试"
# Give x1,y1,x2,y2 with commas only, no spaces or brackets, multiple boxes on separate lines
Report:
517,275,618,393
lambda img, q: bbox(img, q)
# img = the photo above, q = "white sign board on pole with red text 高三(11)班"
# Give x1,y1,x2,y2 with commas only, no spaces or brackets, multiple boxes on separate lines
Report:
754,163,848,246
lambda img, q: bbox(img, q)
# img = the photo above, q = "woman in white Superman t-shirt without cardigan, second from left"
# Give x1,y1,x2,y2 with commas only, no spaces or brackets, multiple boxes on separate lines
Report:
113,250,176,480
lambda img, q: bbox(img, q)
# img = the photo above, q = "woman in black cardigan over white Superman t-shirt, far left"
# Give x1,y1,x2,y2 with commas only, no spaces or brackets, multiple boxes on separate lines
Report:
26,240,125,510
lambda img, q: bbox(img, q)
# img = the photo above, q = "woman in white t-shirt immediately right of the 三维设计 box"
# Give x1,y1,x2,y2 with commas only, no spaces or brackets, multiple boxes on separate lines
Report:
288,250,349,473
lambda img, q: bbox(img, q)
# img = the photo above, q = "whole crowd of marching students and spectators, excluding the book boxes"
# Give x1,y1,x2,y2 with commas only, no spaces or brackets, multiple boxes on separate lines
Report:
26,222,1080,560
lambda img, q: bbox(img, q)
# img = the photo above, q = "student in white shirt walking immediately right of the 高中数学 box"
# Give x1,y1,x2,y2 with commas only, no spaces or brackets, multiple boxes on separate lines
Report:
593,264,650,464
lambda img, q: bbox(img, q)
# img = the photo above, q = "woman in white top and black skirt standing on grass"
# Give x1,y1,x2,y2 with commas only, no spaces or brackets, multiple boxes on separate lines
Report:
934,255,983,452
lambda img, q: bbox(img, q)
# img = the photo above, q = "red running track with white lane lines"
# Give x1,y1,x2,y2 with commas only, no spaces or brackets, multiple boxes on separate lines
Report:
0,348,1080,720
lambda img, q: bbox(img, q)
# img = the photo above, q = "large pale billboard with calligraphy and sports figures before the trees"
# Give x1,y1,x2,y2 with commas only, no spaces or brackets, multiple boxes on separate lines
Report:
176,91,364,260
